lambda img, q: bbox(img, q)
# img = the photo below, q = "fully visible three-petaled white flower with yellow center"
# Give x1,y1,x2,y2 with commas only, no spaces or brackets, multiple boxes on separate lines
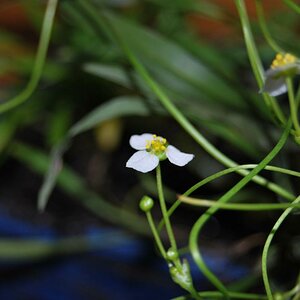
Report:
126,133,194,173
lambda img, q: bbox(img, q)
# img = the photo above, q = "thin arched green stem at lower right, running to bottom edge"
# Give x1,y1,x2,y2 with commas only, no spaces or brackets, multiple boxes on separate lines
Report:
262,196,300,300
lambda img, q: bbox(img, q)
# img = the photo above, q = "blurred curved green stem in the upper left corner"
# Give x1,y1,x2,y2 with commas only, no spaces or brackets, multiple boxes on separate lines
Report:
0,0,58,113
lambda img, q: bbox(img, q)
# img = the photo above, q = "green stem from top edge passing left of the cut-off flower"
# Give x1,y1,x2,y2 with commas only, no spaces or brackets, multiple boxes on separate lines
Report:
235,0,286,124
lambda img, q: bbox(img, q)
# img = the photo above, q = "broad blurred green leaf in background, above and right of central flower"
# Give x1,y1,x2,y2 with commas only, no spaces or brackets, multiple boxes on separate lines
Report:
105,13,246,109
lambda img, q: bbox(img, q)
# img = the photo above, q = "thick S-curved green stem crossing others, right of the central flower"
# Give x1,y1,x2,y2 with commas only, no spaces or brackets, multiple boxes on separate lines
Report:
189,120,291,298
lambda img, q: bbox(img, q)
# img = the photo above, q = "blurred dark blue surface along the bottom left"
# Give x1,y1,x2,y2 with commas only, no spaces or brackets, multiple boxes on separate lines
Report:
0,206,246,300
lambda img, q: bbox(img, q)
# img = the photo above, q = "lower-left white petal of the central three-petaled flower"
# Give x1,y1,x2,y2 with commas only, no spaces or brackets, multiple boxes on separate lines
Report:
126,150,159,173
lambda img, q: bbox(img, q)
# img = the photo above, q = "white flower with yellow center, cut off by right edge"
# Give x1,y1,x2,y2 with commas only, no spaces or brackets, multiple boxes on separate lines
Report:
261,53,300,97
